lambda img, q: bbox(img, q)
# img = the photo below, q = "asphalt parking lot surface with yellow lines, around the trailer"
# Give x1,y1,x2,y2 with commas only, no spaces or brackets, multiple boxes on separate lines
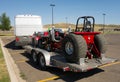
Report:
1,34,120,82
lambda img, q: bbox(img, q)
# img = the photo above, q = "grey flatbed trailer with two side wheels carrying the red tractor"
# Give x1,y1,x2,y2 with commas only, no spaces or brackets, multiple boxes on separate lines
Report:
24,45,117,72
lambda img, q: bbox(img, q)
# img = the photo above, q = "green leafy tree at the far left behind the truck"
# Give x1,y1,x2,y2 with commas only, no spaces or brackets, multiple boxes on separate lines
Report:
0,13,11,31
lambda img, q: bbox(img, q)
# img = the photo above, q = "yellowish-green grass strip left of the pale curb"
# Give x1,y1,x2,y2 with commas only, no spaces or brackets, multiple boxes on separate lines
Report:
0,45,10,82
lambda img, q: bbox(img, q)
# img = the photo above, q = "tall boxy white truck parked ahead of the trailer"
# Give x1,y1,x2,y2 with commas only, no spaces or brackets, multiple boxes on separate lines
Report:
14,15,43,46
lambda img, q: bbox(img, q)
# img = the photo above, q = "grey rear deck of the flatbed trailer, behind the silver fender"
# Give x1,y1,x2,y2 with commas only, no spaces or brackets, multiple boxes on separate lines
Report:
51,52,116,72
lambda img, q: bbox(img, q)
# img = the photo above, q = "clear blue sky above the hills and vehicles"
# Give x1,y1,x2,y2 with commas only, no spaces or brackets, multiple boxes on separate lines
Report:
0,0,120,25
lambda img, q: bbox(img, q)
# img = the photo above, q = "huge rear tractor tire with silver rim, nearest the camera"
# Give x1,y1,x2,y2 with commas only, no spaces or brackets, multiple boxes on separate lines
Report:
62,33,87,63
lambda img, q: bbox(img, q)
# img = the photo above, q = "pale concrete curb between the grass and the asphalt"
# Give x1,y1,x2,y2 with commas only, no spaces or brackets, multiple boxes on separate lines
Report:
0,38,26,82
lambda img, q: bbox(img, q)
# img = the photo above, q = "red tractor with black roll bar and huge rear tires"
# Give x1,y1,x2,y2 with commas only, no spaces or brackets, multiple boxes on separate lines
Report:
32,16,106,63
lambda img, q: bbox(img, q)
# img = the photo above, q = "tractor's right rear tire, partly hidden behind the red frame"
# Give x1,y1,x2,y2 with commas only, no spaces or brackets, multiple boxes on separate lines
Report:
94,34,107,54
